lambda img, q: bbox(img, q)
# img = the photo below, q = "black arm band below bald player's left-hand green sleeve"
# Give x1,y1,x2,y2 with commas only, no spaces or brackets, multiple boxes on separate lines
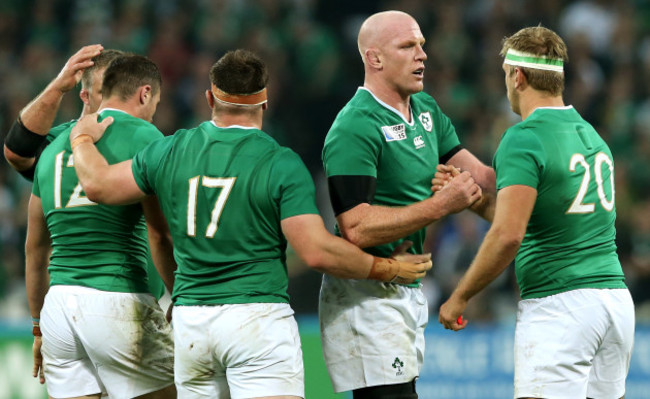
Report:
327,175,377,216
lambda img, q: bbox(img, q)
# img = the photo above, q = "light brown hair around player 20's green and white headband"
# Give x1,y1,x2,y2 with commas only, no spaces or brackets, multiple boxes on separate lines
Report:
501,26,569,96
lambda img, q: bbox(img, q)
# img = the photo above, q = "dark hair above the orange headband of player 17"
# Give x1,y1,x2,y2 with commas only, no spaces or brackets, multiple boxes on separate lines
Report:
210,49,269,94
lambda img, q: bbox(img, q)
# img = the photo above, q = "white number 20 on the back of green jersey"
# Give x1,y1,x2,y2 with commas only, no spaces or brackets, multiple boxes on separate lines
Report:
567,152,615,213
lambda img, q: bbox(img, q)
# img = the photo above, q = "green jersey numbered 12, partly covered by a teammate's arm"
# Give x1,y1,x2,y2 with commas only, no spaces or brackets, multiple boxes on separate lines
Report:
33,109,163,292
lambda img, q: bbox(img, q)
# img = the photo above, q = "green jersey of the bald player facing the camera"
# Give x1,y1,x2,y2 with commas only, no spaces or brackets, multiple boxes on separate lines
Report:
323,87,460,286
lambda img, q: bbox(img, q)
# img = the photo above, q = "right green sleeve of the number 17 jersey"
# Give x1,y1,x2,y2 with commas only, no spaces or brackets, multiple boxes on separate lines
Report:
271,149,319,219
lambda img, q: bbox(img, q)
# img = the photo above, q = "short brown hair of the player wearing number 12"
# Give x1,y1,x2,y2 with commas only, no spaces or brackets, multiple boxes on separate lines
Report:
102,55,162,100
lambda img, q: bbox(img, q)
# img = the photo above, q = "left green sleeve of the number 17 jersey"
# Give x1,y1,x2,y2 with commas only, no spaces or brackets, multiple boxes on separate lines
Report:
131,136,174,194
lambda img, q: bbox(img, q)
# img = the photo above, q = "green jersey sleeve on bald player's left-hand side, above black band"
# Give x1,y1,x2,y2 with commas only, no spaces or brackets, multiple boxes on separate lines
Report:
323,110,382,178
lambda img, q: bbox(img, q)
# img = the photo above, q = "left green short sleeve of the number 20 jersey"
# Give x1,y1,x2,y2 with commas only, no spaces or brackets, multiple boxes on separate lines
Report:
493,128,545,190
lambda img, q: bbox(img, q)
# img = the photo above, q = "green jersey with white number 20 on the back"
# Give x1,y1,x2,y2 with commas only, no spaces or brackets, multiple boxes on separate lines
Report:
493,106,625,299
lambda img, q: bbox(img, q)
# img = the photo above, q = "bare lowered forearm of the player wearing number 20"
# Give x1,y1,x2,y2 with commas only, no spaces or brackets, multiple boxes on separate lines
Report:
452,227,521,301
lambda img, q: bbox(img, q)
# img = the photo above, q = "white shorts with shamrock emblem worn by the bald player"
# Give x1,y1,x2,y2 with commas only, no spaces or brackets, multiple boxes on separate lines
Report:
319,275,429,392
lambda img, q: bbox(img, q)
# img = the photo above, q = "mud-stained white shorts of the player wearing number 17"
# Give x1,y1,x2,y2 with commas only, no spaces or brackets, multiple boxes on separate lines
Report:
172,303,305,399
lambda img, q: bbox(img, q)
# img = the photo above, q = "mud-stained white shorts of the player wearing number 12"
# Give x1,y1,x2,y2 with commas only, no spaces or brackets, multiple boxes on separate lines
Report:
40,285,174,399
